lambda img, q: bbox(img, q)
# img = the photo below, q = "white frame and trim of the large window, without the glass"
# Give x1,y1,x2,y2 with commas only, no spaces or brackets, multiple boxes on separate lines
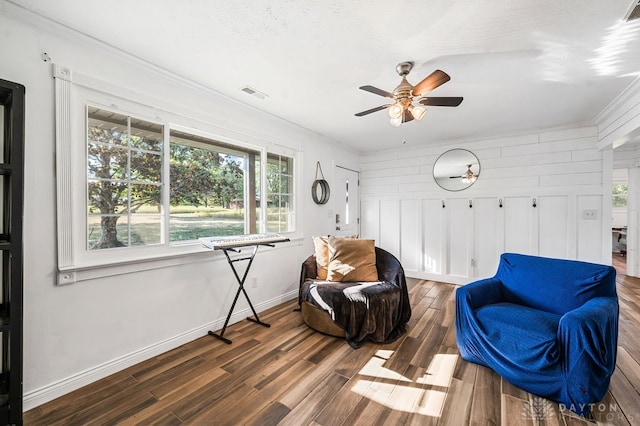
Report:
53,64,302,285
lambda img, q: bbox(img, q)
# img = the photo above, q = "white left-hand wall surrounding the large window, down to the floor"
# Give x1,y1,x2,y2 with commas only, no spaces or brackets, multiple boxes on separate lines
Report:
0,8,359,409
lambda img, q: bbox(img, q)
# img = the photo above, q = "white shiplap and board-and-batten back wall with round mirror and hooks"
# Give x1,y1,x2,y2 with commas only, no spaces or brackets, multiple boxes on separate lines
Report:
360,126,612,284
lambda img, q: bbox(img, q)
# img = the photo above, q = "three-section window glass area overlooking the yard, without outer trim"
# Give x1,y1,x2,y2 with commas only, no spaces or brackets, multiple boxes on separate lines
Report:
86,107,295,251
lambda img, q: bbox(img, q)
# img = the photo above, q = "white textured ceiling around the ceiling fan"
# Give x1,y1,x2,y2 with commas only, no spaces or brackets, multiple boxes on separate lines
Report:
9,0,640,152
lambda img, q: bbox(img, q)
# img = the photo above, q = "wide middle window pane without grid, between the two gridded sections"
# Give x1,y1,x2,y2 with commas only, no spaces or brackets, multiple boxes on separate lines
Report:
169,130,261,241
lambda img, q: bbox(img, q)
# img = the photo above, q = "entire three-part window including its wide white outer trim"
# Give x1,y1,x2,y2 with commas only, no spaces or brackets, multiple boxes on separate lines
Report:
52,64,300,284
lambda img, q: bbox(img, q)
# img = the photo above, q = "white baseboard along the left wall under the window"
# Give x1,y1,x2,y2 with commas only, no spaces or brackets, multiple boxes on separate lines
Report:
23,290,298,411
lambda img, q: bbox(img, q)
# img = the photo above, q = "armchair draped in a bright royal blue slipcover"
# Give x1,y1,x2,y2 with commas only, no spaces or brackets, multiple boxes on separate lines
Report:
456,253,618,414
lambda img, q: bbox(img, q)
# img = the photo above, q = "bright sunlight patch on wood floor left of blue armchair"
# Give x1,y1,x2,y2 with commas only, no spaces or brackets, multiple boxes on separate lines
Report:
351,350,458,417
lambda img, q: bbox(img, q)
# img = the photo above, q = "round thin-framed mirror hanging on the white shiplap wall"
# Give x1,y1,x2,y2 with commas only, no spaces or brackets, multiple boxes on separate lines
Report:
433,148,480,191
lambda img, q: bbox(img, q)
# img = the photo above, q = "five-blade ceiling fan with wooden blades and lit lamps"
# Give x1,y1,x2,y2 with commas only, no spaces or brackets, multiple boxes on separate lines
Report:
355,62,462,127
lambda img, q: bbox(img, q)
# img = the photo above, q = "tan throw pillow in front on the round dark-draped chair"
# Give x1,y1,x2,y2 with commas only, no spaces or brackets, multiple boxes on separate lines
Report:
327,237,378,281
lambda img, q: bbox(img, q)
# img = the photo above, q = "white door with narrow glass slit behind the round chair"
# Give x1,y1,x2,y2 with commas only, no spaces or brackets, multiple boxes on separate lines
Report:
334,166,360,235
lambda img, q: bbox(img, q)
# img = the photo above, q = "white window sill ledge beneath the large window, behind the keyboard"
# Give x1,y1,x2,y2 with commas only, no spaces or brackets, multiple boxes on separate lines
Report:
58,237,304,285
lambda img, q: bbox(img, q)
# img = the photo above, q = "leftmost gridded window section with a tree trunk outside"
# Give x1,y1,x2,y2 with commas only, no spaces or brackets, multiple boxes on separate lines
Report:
87,107,162,250
